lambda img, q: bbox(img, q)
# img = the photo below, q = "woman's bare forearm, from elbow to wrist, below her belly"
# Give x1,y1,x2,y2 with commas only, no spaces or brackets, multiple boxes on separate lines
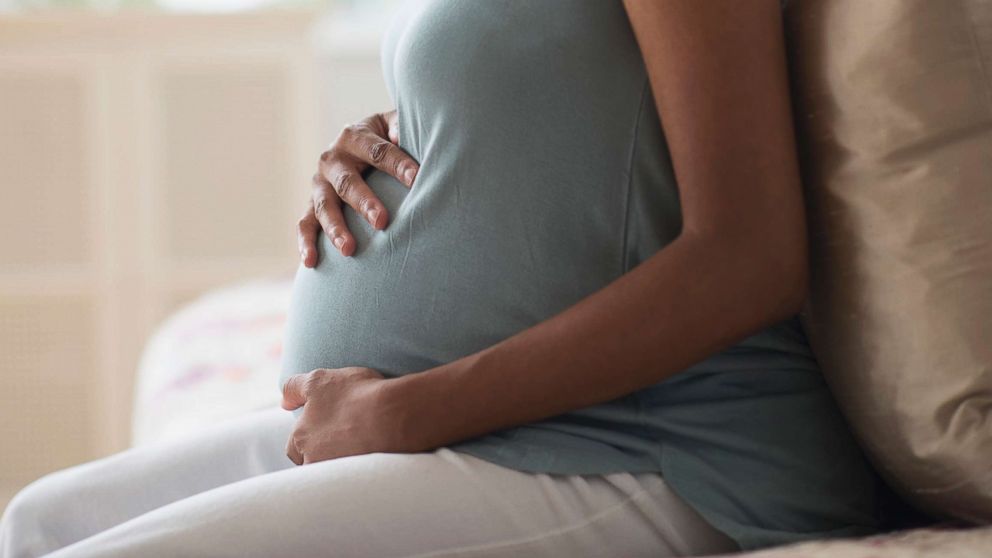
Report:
384,230,806,449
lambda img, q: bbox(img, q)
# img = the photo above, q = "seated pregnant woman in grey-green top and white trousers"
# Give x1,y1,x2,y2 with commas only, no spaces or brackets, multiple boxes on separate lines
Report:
2,0,877,558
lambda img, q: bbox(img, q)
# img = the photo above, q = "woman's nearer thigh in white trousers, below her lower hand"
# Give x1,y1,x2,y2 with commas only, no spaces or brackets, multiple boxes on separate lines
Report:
40,448,736,558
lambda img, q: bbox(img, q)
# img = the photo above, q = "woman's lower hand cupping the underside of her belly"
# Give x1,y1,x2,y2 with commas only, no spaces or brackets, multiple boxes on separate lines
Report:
282,367,412,465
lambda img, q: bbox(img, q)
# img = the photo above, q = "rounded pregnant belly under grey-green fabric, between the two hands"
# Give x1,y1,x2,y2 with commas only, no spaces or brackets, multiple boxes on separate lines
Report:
280,169,620,396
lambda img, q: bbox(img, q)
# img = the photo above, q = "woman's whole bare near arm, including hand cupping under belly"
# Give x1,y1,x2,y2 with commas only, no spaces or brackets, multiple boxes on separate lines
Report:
283,0,808,464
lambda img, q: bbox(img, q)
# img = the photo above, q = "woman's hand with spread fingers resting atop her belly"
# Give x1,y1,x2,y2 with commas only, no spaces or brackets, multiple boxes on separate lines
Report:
297,110,420,267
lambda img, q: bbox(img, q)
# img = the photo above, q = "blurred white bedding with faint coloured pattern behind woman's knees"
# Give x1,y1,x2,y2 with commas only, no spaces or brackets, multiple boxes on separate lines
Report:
131,278,292,445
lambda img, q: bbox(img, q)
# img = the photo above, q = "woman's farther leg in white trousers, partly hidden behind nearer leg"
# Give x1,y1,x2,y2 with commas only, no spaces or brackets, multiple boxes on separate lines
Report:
0,407,295,558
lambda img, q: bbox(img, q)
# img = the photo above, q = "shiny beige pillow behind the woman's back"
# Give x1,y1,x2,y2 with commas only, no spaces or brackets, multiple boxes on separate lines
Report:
784,0,992,522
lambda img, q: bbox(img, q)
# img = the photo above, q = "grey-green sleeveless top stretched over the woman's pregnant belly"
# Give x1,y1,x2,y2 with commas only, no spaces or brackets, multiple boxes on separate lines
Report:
280,0,876,549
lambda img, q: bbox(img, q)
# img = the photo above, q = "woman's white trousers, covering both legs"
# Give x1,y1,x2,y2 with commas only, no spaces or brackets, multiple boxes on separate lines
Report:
0,407,737,558
